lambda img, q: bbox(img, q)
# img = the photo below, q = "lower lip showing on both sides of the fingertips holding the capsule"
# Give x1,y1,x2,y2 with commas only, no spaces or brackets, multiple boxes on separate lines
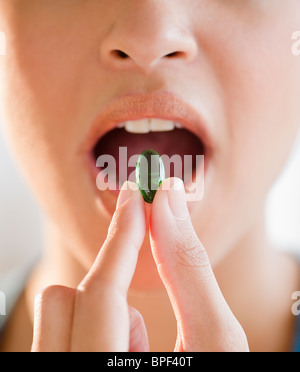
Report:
87,149,210,216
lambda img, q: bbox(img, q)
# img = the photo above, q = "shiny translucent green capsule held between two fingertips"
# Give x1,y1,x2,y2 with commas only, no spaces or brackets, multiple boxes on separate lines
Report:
135,150,166,204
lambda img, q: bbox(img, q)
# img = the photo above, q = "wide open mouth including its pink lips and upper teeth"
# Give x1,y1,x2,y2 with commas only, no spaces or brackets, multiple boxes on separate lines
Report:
83,90,215,215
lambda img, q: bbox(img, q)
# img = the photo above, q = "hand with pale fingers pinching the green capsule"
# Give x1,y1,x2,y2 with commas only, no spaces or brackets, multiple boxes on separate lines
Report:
32,179,249,352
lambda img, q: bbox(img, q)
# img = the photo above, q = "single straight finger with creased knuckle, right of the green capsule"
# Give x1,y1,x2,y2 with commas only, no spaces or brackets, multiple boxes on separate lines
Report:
150,179,249,352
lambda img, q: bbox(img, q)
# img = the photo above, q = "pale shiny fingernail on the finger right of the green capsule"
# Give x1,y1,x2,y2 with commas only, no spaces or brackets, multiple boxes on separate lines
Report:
168,178,189,221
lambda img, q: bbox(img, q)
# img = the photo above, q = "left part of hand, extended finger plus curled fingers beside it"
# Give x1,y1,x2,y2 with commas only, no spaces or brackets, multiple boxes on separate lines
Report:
32,184,149,352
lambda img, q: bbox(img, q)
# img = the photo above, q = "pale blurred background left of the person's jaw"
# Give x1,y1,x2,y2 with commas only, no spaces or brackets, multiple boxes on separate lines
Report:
0,122,42,302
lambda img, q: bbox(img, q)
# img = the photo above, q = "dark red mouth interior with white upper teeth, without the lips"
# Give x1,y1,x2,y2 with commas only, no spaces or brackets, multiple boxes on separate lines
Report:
92,118,206,192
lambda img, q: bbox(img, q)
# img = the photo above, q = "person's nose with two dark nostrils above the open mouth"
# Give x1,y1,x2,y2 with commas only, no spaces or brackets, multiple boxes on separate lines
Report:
101,0,198,70
